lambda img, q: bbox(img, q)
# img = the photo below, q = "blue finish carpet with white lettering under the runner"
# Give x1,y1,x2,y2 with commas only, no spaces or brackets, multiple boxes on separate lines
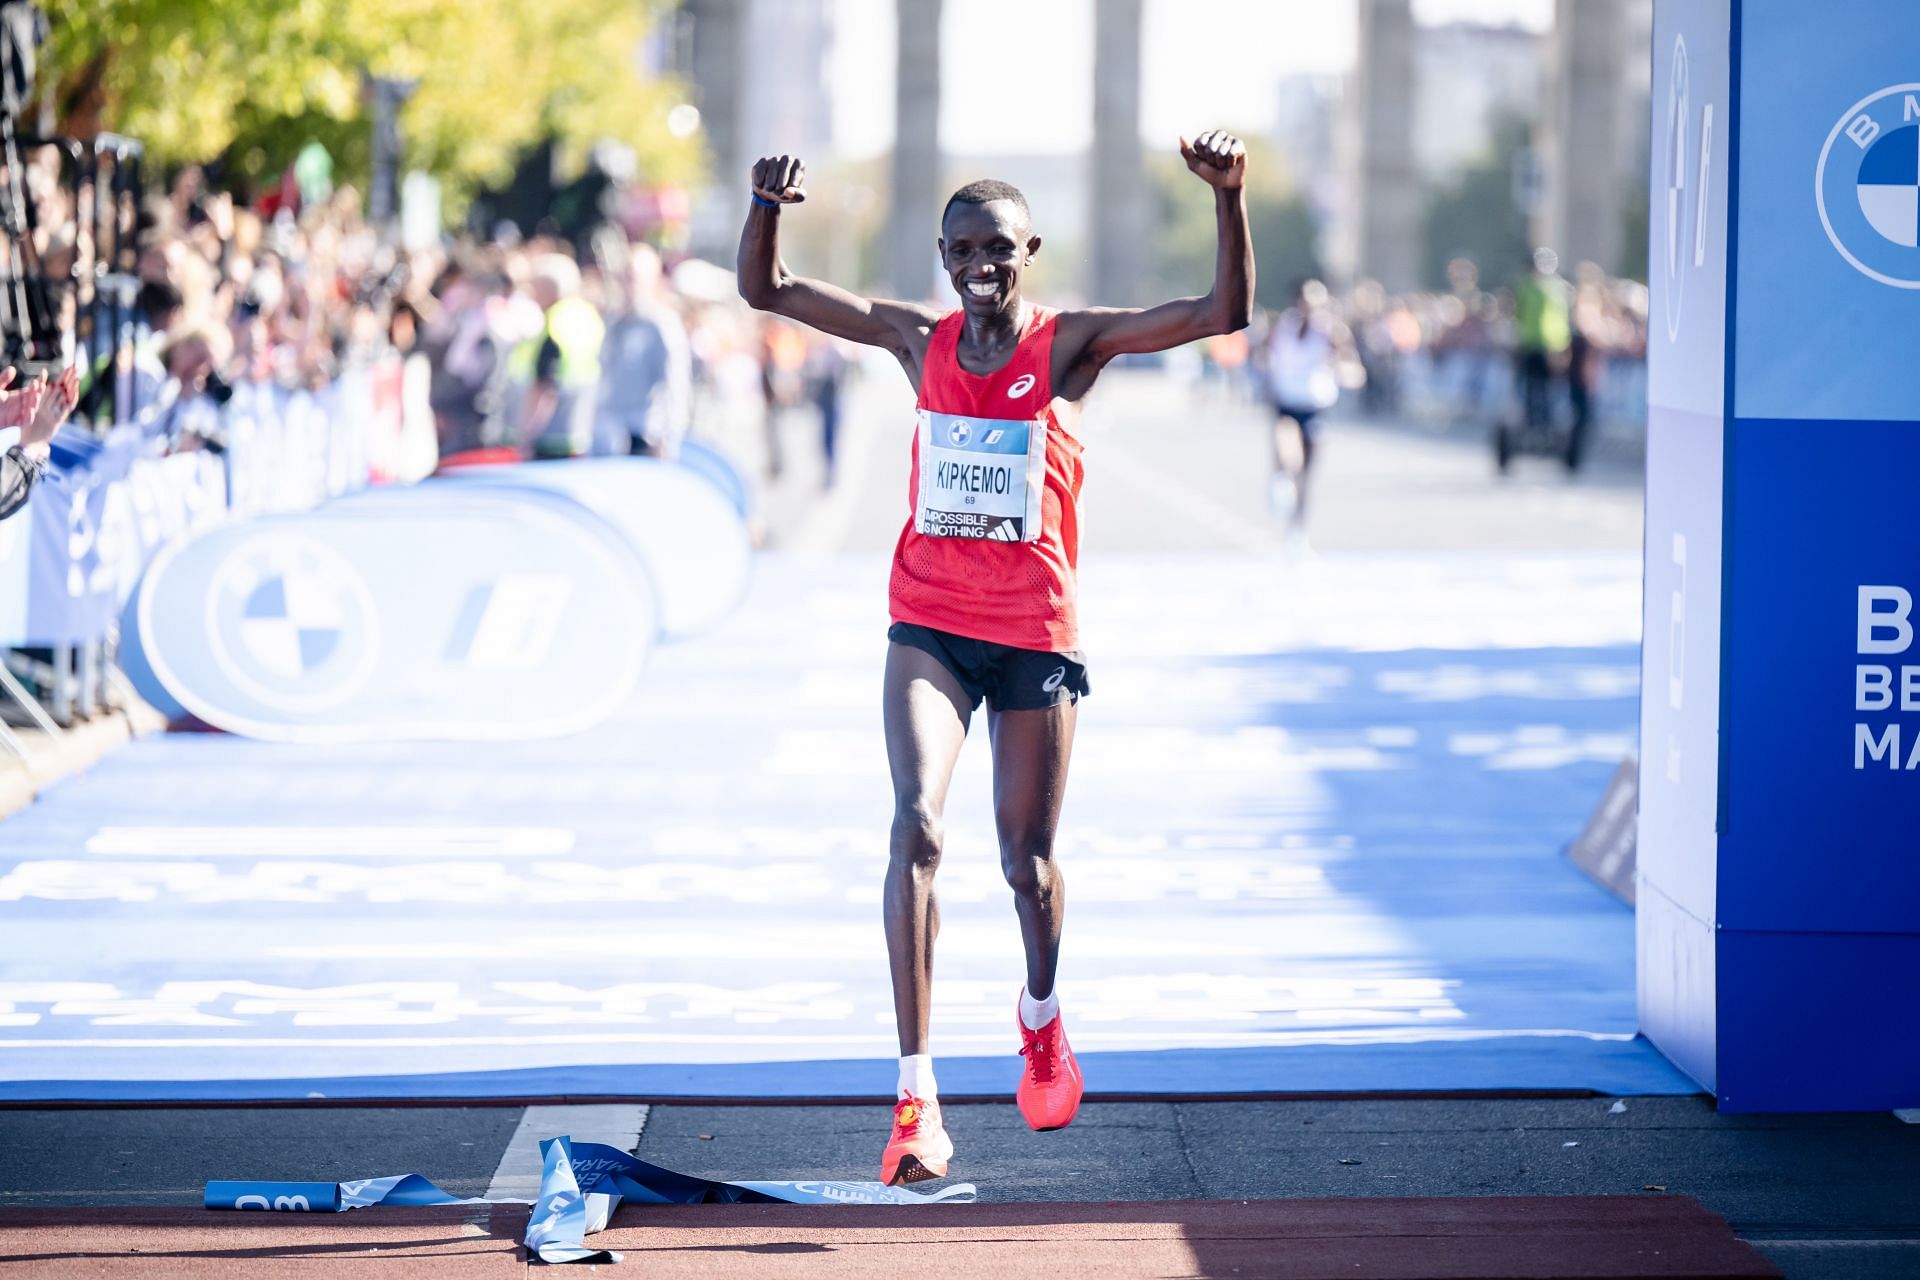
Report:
0,557,1693,1100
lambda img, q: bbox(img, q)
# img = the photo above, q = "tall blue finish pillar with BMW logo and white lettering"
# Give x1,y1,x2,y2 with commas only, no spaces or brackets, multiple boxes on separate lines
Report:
1638,0,1920,1111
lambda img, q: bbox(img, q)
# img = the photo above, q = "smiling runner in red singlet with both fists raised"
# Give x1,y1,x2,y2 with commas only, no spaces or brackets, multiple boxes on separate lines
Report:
739,130,1254,1186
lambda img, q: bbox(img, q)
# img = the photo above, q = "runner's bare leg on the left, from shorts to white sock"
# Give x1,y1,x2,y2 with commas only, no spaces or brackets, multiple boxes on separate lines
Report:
881,645,972,1055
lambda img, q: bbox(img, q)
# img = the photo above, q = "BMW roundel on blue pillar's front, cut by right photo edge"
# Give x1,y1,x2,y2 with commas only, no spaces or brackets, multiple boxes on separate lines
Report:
1814,84,1920,290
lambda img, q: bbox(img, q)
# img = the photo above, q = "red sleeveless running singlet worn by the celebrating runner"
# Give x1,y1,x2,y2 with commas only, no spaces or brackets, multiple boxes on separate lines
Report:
887,305,1085,652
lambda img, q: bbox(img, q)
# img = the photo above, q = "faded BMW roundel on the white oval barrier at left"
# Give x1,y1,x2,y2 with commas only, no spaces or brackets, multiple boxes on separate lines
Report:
207,533,378,712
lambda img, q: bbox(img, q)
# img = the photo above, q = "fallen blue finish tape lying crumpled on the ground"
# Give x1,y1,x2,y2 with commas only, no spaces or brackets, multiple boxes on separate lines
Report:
205,1138,975,1263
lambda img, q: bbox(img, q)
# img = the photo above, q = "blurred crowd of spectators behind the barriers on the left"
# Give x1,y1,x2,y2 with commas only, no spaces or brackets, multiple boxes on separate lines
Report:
5,157,817,483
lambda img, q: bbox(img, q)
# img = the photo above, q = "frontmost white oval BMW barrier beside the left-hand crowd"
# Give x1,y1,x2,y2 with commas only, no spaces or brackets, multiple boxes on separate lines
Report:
123,486,657,743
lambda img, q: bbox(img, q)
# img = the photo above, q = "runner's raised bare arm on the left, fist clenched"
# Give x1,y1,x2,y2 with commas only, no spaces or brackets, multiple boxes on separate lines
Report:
735,155,939,388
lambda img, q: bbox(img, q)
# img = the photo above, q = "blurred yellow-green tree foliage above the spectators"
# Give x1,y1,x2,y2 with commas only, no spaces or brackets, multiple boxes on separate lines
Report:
42,0,699,208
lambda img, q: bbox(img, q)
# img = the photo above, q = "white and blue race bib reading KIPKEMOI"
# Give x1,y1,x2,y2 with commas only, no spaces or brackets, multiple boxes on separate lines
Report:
914,409,1046,543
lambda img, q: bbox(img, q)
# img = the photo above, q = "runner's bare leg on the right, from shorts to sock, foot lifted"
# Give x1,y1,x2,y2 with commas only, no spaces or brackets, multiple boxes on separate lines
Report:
987,702,1079,1000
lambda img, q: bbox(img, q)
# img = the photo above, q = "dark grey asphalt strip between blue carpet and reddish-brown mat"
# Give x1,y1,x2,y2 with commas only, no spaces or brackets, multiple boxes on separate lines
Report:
0,1098,1920,1278
